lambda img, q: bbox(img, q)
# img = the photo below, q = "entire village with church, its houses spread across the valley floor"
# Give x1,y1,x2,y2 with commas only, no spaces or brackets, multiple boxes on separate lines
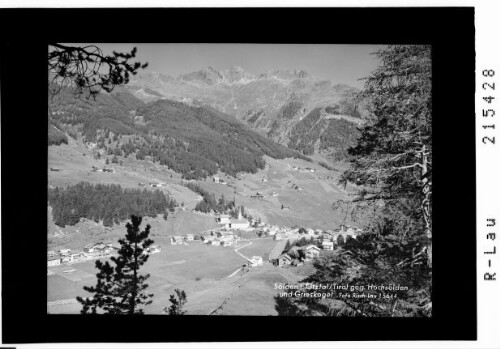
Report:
47,198,362,274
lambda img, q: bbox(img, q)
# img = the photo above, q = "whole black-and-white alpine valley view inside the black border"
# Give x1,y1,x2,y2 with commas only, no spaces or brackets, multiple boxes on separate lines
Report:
47,43,432,317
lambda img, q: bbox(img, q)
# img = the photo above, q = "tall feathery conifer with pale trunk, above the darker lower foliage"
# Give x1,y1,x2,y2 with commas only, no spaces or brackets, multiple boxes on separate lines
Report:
341,45,432,264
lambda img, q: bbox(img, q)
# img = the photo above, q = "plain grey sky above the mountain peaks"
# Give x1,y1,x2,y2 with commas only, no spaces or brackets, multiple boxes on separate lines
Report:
94,44,382,88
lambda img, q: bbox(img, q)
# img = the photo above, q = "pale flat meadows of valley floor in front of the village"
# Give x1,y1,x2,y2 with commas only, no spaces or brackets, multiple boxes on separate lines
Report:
47,238,316,315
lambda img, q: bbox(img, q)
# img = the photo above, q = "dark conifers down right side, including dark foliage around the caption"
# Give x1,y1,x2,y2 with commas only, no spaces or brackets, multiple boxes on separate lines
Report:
276,45,432,317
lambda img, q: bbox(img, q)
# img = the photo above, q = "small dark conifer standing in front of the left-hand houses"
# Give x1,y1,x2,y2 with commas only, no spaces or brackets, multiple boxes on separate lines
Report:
77,215,153,315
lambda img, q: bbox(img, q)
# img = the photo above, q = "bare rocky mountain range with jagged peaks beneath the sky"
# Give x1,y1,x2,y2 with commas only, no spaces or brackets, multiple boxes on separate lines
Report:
128,67,367,158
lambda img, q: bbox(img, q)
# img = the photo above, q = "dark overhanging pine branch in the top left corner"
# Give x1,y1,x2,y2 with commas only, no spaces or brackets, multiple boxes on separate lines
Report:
48,43,148,98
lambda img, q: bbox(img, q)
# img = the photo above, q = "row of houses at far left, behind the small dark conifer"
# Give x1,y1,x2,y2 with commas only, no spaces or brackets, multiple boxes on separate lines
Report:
47,242,161,267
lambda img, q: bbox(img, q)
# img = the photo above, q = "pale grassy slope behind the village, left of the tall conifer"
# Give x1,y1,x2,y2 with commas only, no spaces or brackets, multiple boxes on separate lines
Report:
189,157,354,229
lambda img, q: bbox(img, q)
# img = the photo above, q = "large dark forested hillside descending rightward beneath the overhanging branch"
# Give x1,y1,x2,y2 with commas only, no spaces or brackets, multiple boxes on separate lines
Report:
49,90,305,179
